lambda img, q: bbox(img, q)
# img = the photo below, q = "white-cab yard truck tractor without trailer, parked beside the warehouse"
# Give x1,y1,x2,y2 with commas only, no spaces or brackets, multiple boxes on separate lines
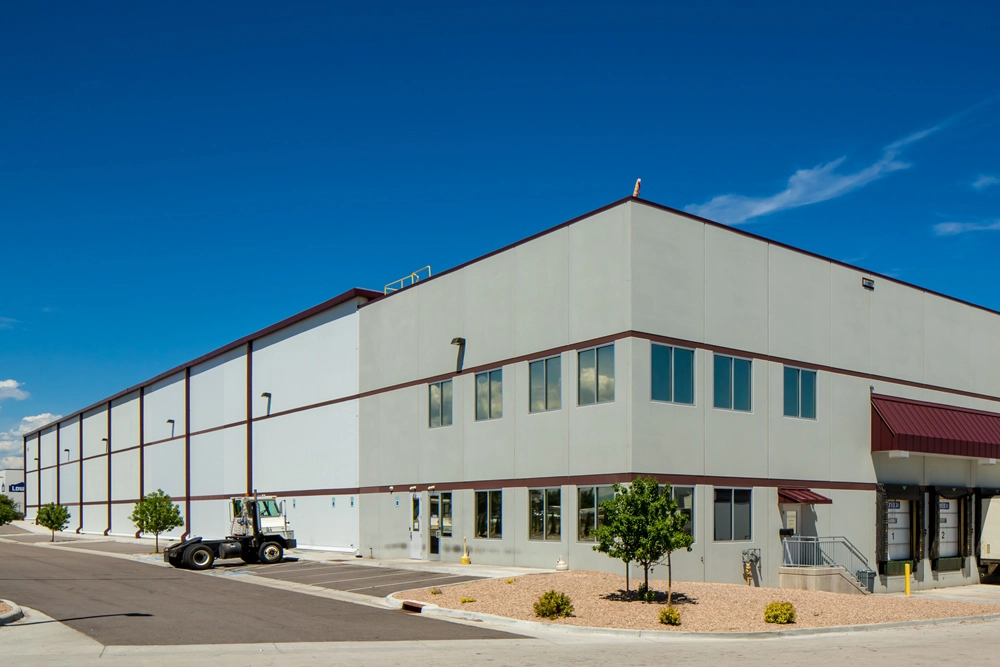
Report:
163,493,296,570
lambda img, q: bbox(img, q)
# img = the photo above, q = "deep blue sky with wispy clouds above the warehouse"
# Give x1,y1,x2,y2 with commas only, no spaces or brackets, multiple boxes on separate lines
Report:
0,2,1000,464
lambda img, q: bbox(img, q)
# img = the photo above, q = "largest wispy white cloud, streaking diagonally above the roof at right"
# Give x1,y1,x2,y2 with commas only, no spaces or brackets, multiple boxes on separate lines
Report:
685,126,950,225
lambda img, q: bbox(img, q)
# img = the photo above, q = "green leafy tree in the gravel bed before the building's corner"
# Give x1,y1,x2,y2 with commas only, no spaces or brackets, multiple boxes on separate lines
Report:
593,477,694,605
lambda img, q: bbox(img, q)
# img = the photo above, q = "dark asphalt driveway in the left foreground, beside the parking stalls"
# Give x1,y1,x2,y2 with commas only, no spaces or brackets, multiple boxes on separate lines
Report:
0,542,514,646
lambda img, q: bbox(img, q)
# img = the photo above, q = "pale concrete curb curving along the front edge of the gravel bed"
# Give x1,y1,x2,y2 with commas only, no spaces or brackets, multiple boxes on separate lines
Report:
385,595,1000,640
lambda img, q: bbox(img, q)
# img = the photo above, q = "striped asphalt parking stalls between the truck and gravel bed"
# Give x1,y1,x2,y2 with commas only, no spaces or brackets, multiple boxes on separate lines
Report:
215,559,481,598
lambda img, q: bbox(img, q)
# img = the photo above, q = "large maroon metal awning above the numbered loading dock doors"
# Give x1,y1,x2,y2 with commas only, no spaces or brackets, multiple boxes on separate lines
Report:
872,394,1000,459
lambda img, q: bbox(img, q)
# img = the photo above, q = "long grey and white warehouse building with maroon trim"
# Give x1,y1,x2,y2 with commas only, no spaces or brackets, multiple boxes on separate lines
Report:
24,197,1000,591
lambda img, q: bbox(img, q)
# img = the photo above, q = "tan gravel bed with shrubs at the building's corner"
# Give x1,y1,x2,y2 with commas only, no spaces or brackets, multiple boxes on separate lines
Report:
394,571,1000,632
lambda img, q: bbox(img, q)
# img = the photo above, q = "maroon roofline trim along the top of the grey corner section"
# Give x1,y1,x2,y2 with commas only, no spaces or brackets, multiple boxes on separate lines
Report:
360,196,1000,326
